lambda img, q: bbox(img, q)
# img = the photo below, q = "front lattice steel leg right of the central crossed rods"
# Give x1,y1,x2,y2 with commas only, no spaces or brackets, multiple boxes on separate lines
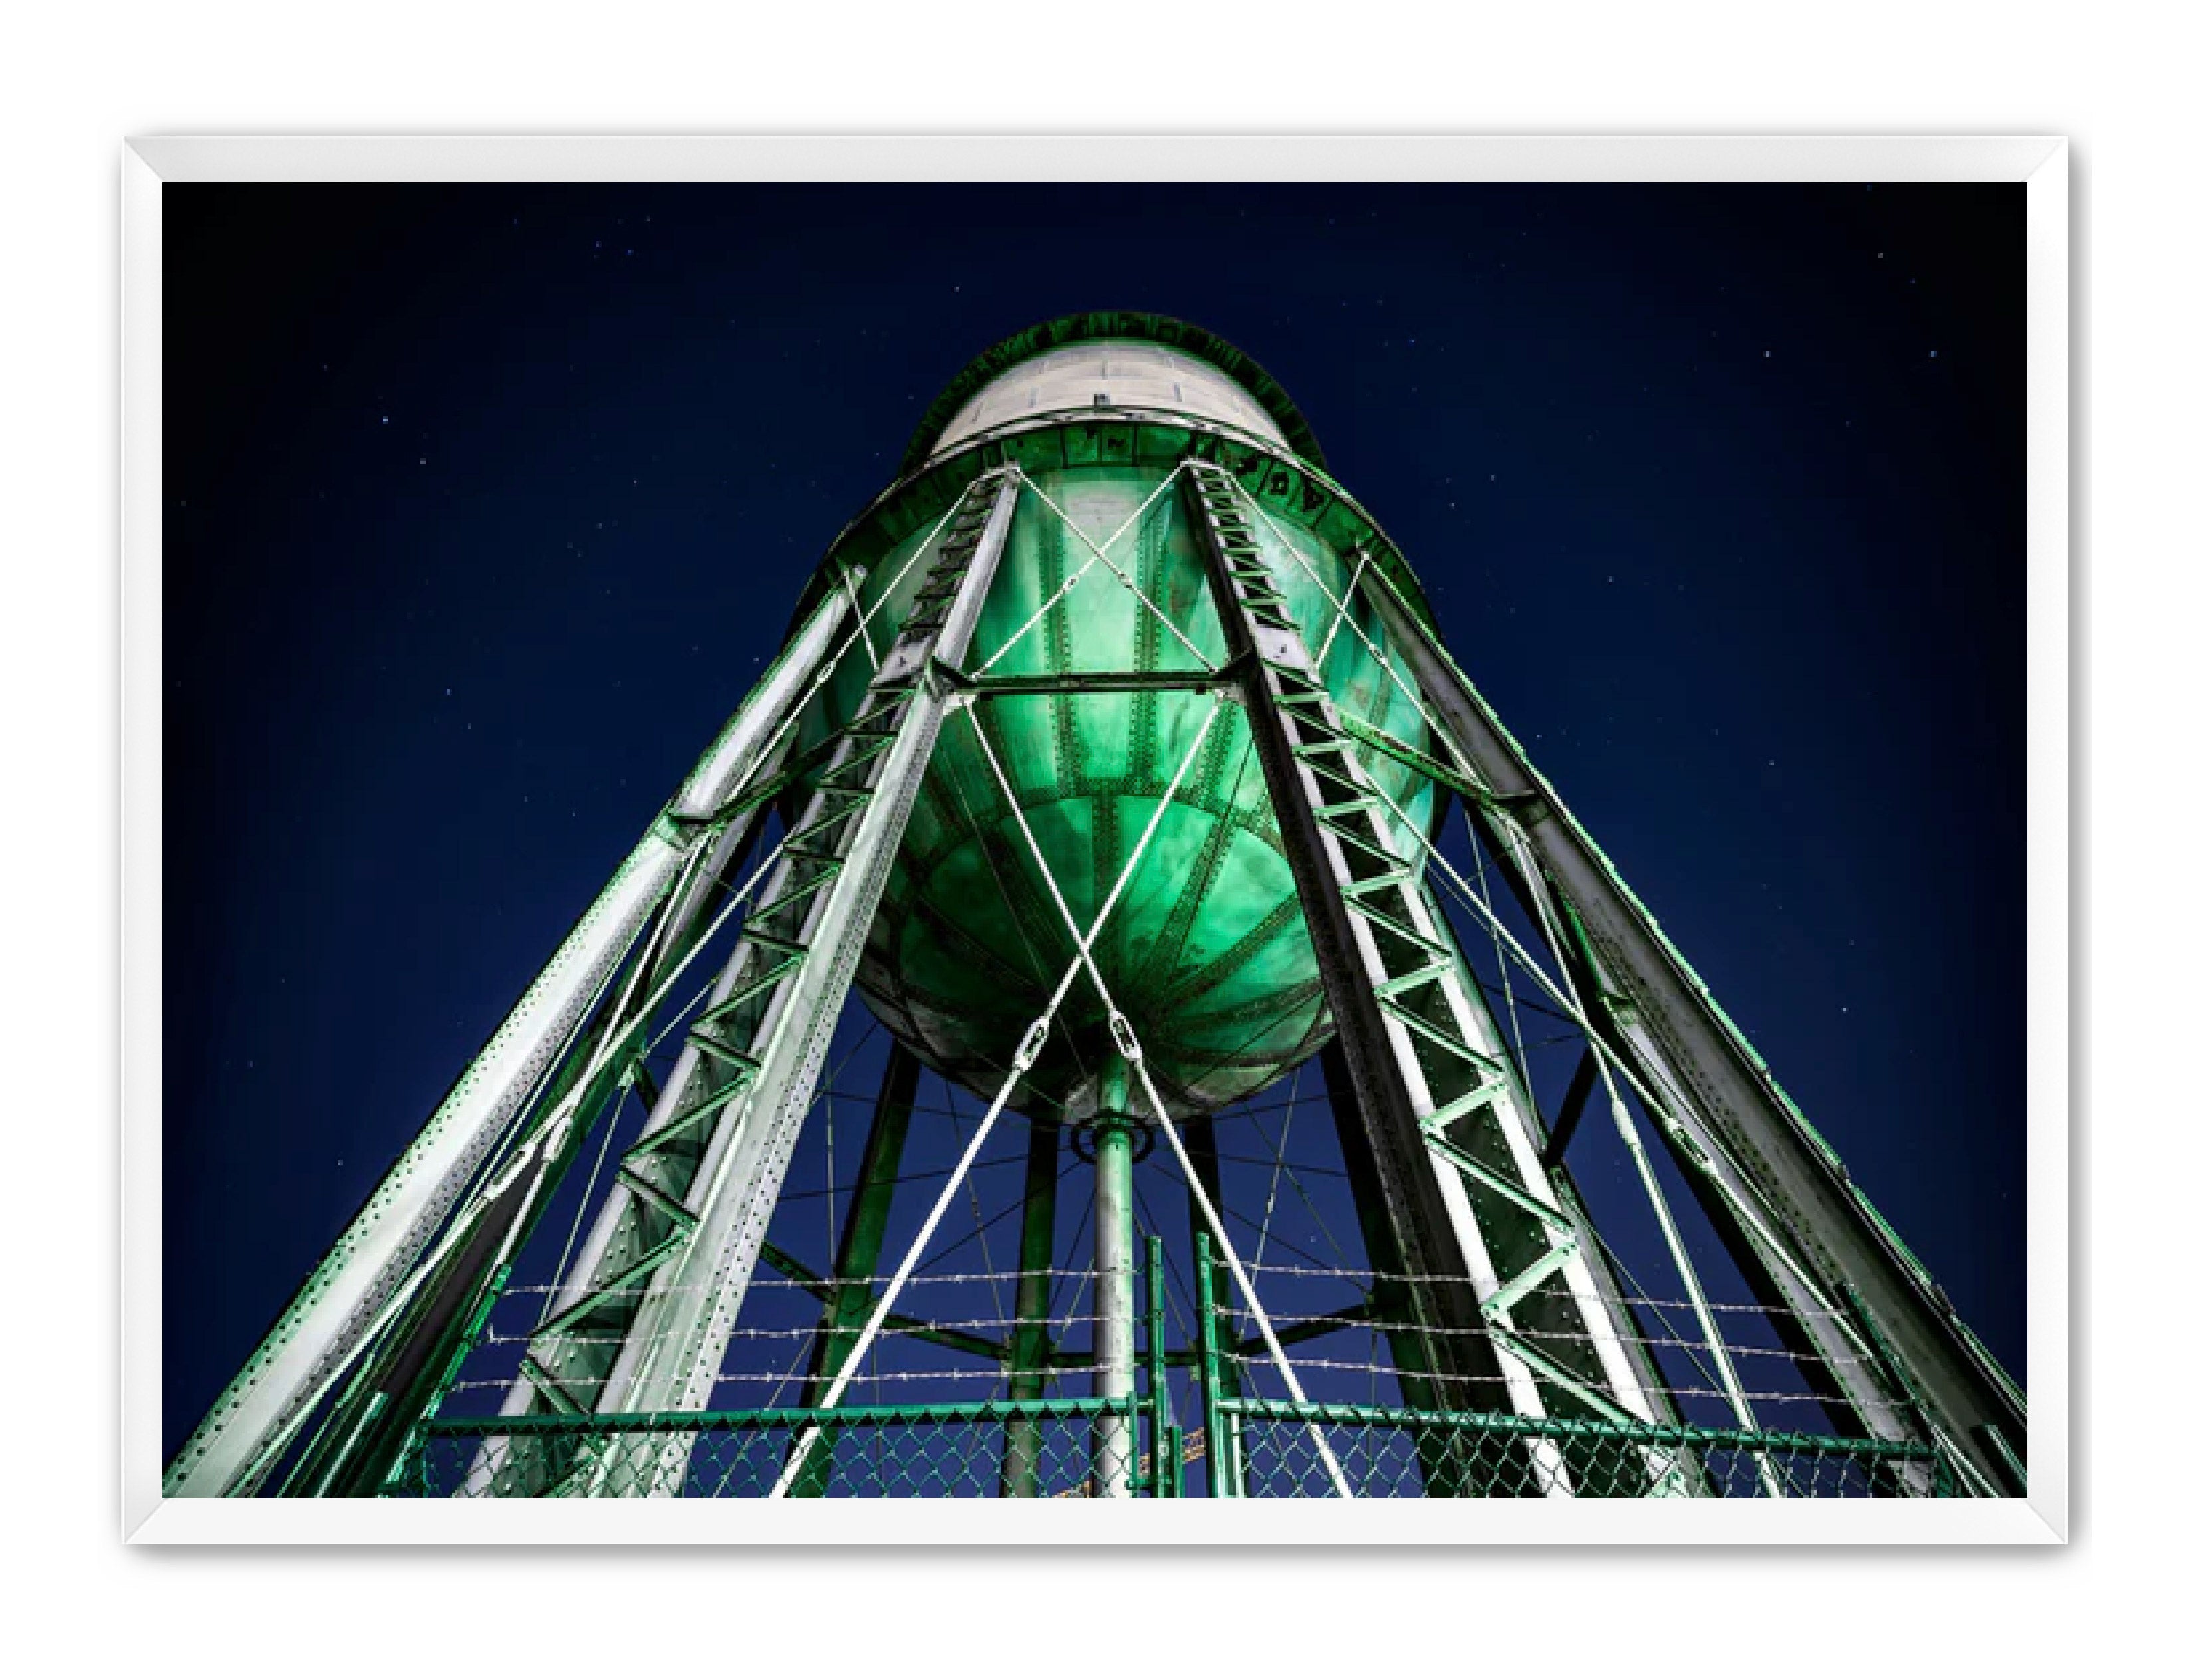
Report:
1186,461,1648,1492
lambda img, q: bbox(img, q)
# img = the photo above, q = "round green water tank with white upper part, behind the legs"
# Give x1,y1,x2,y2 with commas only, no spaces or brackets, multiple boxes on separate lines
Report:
801,313,1436,1114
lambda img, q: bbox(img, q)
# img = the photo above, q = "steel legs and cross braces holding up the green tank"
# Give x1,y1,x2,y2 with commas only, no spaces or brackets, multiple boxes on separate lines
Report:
168,413,2023,1497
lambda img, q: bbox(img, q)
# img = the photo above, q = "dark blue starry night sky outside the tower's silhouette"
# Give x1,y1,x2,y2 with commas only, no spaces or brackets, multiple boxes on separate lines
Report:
164,183,2025,1446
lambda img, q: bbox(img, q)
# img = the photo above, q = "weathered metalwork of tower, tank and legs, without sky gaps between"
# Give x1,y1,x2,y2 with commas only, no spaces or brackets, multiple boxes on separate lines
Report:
168,313,2025,1494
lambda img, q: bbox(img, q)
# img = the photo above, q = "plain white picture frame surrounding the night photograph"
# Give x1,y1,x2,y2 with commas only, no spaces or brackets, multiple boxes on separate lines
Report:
120,136,2077,1546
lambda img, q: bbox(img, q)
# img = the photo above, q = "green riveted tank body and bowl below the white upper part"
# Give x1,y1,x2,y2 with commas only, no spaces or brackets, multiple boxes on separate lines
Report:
805,453,1440,1112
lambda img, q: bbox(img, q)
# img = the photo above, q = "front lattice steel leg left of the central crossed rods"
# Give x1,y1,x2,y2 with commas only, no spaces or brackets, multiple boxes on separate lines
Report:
497,466,1018,1494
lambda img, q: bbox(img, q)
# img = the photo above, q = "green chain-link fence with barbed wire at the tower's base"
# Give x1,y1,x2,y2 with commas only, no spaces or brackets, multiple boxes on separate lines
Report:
368,1241,1981,1499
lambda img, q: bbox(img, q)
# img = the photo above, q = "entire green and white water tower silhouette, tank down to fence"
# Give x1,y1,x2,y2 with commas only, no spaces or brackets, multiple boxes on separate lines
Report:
166,313,2025,1497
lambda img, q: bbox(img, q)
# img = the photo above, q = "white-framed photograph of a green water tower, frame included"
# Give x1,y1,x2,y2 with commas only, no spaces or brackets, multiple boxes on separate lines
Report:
122,138,2071,1544
